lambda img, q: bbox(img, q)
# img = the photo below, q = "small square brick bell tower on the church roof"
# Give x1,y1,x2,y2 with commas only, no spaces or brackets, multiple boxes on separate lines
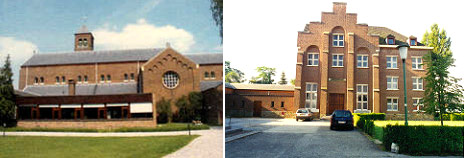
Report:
74,25,94,52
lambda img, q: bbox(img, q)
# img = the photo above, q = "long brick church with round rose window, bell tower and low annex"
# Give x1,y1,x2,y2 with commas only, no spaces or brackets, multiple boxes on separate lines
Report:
16,25,223,128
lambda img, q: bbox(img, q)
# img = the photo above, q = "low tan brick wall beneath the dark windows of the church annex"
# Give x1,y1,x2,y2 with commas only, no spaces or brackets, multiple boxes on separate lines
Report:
17,119,157,129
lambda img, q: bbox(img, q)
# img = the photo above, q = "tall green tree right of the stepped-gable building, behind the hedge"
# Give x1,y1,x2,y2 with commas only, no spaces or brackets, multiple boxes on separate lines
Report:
422,24,463,126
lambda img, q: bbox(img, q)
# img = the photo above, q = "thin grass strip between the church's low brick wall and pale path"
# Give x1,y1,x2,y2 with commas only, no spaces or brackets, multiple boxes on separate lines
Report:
0,123,210,132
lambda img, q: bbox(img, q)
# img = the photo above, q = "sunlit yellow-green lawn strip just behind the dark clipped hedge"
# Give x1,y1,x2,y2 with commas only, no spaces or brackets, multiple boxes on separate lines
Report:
373,120,464,141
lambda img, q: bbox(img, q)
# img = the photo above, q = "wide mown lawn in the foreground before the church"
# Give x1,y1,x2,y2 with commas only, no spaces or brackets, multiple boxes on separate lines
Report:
0,135,198,158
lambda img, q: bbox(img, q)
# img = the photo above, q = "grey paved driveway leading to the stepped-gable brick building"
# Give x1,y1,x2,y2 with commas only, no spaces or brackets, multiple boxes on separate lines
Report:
226,118,450,158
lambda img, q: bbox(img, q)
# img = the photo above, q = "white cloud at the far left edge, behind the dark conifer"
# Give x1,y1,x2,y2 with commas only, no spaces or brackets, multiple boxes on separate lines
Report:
0,36,38,88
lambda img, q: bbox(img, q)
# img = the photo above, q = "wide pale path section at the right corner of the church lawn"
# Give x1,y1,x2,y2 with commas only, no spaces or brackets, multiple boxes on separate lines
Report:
165,127,224,158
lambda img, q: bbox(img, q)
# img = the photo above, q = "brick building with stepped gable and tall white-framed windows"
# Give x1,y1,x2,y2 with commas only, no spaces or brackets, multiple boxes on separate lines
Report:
294,2,432,116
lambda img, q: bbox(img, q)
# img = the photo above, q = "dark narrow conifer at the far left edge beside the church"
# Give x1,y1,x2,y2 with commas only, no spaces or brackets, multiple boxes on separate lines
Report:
0,54,15,125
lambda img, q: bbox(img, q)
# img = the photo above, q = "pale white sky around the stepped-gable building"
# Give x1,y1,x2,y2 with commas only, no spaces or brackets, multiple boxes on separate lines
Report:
223,0,465,85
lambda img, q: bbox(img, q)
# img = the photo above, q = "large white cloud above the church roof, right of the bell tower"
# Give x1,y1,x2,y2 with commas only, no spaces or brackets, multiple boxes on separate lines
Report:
92,19,195,52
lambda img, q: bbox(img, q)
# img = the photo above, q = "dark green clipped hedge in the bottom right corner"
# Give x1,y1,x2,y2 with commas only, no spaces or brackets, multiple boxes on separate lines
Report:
383,125,464,155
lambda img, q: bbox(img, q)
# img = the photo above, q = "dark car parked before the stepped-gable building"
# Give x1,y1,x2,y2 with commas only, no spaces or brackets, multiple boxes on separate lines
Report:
330,110,354,130
